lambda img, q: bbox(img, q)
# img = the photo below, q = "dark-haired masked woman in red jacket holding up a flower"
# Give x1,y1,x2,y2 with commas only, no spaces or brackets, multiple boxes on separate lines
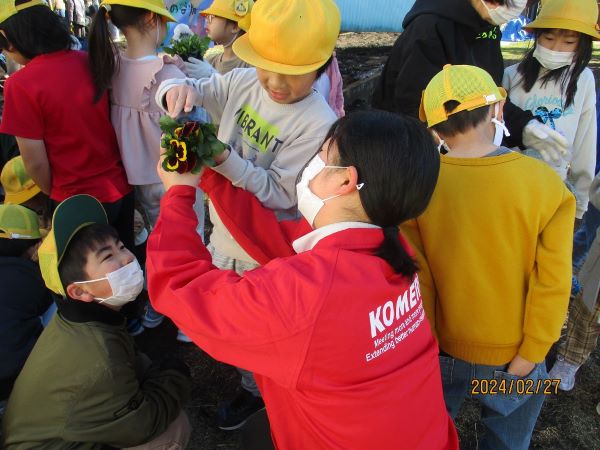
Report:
147,112,458,450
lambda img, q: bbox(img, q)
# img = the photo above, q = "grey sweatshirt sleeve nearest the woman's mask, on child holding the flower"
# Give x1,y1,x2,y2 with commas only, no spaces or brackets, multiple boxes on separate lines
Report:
213,133,327,210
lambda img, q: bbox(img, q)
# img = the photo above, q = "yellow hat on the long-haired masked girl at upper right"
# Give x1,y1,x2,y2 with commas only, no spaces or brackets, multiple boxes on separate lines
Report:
524,0,600,40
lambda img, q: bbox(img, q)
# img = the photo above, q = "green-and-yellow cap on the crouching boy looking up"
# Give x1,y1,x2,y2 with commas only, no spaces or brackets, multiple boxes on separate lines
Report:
38,195,108,296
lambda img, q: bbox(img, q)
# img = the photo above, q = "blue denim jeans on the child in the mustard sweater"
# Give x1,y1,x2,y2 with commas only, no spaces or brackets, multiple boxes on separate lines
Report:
440,355,548,450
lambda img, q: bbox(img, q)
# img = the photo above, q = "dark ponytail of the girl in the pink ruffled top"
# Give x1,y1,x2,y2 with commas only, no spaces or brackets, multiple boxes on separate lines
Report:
89,5,119,102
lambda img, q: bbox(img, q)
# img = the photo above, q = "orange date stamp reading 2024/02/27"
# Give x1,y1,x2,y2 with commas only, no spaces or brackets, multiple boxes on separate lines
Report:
471,378,560,395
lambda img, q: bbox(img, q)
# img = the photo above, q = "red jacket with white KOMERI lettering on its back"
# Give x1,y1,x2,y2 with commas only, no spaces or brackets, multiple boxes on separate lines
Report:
147,186,458,450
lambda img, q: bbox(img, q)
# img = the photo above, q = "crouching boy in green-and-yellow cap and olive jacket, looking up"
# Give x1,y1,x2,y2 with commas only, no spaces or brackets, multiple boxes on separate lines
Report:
2,195,190,449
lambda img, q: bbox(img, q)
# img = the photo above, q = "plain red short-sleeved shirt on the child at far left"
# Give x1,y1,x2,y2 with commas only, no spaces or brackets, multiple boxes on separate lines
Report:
0,50,129,203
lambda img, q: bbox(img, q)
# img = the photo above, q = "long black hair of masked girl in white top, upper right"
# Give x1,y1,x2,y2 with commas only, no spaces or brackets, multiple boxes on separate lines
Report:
517,29,592,109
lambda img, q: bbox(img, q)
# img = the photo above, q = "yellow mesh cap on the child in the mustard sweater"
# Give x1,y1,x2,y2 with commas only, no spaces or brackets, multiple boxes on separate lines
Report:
419,64,506,127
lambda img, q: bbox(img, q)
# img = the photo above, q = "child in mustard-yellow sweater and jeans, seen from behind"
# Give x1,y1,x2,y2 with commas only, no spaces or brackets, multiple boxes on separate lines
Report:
403,65,575,450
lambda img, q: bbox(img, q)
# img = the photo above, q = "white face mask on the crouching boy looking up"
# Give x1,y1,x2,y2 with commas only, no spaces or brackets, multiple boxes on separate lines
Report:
73,259,144,306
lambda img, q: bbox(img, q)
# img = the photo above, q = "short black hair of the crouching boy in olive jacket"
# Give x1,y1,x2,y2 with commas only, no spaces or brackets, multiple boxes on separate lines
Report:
58,223,120,291
